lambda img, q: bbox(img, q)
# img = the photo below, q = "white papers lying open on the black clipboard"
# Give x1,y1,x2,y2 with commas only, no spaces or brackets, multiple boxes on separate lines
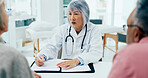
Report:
31,59,91,72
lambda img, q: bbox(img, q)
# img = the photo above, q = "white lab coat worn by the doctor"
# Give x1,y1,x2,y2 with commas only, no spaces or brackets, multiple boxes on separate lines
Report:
38,22,103,64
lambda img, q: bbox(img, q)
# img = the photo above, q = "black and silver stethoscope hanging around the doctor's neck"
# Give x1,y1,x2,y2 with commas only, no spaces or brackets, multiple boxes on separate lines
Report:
65,24,87,56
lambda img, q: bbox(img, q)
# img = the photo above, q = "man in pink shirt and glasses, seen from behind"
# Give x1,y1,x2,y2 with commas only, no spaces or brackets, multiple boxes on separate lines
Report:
108,0,148,78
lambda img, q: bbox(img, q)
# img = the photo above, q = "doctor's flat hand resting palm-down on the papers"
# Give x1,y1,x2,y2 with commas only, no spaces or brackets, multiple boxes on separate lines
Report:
57,58,80,70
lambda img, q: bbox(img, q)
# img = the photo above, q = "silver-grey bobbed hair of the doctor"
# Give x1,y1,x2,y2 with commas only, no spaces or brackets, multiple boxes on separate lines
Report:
68,0,89,26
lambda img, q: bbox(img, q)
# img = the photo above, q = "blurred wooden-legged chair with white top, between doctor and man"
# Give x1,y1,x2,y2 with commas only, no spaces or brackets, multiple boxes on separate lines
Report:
98,25,126,57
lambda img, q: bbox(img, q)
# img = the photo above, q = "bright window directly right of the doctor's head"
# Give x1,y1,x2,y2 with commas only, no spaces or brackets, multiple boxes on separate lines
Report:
86,0,112,24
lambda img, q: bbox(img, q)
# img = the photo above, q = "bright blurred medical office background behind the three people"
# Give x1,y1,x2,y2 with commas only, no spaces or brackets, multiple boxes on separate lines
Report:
2,0,137,78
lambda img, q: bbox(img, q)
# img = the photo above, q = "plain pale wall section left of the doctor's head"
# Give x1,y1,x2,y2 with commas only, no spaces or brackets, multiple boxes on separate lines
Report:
40,0,63,26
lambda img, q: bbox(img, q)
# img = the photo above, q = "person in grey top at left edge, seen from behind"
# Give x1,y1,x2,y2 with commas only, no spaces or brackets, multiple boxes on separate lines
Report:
0,0,41,78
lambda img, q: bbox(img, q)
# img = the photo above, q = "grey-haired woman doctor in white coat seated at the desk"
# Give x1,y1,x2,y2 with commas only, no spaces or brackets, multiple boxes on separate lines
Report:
35,0,103,70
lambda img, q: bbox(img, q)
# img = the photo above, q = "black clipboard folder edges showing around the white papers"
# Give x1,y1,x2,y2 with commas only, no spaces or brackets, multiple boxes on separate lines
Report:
30,59,95,73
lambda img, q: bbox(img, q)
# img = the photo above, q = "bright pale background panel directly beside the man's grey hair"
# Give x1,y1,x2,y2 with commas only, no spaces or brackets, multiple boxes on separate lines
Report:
114,0,137,27
